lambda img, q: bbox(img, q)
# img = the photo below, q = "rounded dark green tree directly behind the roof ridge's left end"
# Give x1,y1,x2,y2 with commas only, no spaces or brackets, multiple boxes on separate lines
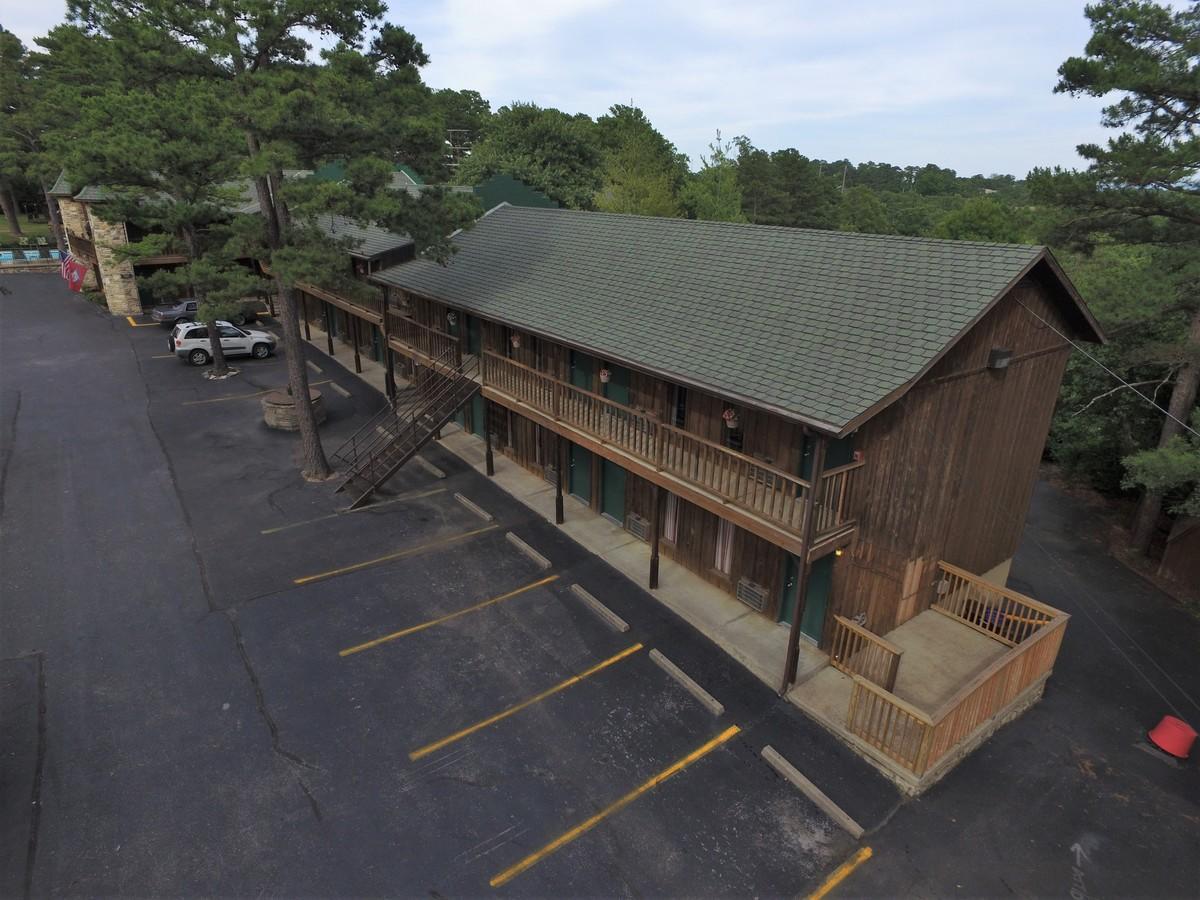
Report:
455,103,602,209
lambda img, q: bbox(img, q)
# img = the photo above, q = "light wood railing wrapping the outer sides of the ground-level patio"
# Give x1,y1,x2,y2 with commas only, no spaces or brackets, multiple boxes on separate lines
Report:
846,563,1070,778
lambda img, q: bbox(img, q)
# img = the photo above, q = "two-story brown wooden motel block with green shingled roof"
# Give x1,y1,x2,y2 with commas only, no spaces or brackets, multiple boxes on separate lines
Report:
345,205,1103,787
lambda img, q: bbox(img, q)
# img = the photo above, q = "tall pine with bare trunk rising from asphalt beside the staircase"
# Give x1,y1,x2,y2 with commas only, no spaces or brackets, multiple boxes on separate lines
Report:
68,0,472,479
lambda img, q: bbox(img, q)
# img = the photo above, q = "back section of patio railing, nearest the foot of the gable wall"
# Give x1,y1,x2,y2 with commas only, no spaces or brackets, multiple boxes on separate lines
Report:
934,563,1061,647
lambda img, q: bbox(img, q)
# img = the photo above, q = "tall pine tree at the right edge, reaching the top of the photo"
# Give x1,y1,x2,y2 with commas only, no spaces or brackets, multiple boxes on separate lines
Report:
1030,0,1200,551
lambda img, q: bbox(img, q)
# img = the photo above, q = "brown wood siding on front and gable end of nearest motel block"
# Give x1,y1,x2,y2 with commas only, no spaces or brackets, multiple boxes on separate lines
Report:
390,274,1075,646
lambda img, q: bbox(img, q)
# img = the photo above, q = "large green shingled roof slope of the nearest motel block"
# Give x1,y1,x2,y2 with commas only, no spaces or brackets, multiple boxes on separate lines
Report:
373,205,1089,432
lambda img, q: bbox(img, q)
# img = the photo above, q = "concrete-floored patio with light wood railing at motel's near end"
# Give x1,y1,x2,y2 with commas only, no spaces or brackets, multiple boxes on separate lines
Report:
788,563,1069,793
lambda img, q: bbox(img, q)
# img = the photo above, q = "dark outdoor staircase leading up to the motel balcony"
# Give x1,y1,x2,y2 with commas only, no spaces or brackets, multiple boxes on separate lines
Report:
334,347,479,509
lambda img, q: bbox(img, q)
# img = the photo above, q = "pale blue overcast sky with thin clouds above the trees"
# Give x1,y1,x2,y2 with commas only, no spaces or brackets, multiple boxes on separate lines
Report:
0,0,1105,175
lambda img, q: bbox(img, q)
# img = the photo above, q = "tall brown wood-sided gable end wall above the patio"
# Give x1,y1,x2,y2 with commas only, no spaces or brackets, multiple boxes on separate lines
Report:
826,275,1073,640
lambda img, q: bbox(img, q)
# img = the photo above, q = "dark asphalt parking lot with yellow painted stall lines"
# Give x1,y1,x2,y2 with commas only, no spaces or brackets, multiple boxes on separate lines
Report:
0,276,898,898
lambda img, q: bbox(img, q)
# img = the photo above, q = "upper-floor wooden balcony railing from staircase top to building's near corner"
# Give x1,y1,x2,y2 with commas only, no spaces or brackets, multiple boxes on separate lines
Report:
484,352,862,535
